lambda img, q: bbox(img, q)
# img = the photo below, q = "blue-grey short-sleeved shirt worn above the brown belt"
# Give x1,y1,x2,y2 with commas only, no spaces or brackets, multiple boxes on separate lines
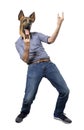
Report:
15,32,49,62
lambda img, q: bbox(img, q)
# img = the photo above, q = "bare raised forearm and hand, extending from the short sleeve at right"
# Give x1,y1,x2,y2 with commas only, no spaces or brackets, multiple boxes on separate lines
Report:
48,13,64,44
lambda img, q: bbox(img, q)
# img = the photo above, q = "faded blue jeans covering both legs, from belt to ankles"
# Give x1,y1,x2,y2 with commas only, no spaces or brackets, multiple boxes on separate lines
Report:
21,61,69,116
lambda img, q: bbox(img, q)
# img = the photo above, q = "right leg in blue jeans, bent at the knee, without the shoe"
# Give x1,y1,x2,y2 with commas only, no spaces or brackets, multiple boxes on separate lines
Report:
46,62,69,116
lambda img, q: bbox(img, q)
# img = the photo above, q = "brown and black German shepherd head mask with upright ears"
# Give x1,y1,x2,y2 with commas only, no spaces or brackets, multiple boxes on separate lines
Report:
18,10,35,38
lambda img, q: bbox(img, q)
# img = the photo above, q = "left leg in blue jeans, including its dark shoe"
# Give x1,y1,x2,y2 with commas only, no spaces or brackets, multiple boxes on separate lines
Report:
16,64,42,123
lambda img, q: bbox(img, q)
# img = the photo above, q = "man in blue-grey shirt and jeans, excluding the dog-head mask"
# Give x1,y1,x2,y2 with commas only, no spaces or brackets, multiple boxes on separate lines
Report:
15,13,72,123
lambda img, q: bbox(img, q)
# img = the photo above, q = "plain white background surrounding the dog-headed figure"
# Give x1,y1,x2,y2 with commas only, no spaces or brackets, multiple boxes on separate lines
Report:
0,0,84,130
